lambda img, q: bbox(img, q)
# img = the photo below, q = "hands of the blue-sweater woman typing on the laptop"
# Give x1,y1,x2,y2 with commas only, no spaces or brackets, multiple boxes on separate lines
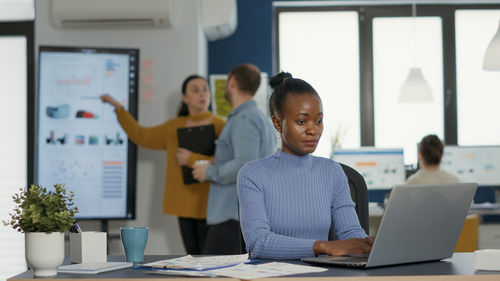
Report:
313,237,374,256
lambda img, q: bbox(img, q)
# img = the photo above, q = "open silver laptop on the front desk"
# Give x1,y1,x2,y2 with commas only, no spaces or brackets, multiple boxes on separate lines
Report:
302,183,477,267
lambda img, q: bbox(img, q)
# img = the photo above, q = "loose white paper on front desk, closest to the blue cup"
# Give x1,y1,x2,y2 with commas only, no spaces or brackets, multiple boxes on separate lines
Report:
142,254,250,270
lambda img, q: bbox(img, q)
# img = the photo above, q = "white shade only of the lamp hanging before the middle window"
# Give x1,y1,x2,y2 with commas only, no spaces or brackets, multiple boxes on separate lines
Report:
399,68,433,102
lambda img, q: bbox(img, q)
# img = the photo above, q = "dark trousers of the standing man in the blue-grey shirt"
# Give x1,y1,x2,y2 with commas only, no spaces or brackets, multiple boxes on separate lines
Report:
203,220,246,255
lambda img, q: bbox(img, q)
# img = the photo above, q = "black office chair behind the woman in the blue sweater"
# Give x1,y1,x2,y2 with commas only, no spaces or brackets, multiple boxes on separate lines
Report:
328,163,370,238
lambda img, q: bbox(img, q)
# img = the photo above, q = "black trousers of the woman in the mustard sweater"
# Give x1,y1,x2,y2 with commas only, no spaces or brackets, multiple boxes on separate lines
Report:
179,217,208,255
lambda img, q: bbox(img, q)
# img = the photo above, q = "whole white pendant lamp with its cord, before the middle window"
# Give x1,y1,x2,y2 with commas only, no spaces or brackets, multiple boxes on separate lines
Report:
399,0,433,102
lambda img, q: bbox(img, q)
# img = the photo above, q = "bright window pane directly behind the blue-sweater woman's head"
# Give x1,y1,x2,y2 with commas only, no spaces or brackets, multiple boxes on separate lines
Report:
279,11,360,157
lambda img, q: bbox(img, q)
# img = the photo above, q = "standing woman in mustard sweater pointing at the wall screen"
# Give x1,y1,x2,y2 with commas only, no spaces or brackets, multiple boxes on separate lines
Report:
101,75,225,254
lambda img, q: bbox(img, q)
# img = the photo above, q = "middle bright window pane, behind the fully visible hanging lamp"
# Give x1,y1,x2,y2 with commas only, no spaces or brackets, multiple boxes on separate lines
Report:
373,17,444,164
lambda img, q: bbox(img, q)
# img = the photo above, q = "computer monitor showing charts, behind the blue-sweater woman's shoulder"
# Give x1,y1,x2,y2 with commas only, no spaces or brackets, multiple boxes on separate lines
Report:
333,147,405,189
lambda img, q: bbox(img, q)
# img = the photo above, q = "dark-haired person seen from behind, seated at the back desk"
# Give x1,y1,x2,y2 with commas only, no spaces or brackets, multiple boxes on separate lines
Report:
406,135,459,184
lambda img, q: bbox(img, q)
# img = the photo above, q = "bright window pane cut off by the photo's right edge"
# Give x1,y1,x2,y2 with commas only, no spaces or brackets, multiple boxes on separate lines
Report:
455,10,500,145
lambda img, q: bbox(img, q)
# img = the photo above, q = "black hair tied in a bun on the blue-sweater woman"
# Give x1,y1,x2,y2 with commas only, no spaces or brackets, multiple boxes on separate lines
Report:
269,72,321,116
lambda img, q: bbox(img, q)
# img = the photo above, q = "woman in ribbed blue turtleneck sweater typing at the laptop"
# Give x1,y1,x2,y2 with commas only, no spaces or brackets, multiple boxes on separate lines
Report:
237,72,373,259
